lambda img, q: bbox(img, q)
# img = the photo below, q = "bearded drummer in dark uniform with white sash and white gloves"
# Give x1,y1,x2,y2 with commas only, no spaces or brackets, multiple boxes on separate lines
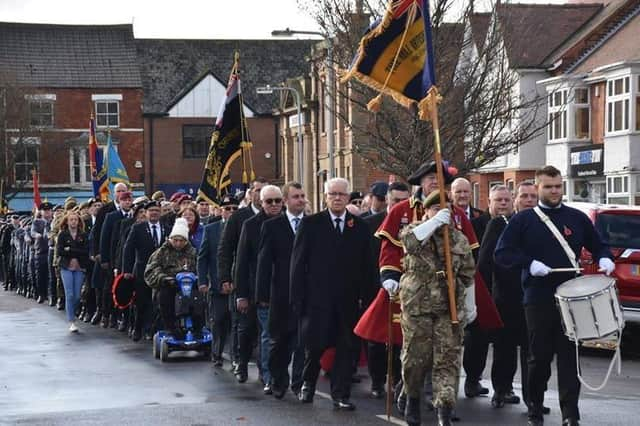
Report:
495,166,615,425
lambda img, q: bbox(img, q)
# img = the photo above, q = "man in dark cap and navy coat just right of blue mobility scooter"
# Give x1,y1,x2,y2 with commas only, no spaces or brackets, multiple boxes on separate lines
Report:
198,195,238,367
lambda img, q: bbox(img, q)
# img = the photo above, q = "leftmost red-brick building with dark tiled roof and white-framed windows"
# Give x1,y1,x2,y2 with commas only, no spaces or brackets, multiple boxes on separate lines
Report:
0,23,144,210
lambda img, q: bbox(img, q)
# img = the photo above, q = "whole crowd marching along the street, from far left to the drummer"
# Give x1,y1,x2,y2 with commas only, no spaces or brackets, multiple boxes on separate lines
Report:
0,162,614,425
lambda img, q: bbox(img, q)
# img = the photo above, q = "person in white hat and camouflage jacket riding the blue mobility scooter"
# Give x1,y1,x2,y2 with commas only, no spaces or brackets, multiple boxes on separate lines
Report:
144,218,202,335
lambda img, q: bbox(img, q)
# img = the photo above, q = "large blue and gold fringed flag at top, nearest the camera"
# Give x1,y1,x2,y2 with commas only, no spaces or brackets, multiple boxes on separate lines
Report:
342,0,439,119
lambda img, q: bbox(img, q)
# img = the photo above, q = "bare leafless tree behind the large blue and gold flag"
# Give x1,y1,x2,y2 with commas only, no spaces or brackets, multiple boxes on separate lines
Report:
298,0,547,177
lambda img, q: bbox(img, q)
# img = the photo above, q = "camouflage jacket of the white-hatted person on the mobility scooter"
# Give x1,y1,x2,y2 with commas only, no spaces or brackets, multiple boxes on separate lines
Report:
144,240,196,289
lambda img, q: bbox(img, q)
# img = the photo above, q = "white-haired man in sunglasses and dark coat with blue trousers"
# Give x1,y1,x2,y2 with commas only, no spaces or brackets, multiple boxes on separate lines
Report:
235,185,282,395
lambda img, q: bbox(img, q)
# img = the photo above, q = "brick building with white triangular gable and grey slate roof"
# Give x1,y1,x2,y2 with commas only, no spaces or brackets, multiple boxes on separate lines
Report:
136,39,312,195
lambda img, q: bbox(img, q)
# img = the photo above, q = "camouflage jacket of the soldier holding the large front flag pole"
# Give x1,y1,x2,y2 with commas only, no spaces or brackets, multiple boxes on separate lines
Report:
400,222,475,318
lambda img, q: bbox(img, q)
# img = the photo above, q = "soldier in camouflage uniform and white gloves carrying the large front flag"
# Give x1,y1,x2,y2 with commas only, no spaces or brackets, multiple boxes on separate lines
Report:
399,191,475,425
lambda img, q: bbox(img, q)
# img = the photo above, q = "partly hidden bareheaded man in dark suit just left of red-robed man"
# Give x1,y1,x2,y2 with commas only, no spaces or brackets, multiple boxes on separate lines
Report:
361,182,411,398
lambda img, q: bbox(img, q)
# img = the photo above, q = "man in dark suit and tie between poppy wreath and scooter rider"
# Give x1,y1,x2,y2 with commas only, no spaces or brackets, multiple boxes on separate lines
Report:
122,201,171,342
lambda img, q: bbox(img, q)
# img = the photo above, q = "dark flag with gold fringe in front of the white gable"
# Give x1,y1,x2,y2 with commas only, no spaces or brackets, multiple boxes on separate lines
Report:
198,52,255,205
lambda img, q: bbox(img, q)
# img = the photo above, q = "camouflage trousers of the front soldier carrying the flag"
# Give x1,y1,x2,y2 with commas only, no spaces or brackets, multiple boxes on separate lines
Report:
400,312,462,408
